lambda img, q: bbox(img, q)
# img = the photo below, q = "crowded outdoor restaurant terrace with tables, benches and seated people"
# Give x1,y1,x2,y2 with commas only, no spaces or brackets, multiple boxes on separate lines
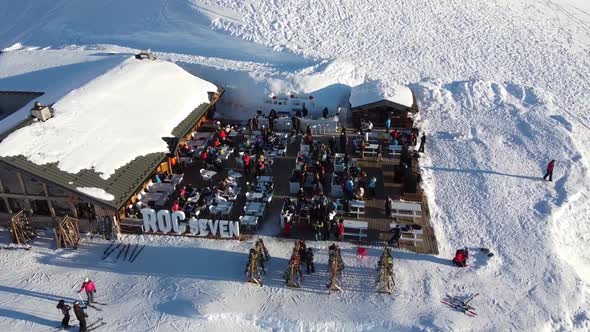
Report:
118,98,436,252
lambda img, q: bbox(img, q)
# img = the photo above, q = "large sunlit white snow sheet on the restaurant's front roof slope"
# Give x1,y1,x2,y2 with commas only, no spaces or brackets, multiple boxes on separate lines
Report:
0,58,217,179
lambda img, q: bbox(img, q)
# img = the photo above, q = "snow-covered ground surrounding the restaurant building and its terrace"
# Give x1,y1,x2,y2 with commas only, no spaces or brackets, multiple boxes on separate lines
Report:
0,0,590,331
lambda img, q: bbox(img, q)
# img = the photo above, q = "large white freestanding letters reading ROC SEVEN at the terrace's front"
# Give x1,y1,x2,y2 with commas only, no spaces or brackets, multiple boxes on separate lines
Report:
141,208,240,238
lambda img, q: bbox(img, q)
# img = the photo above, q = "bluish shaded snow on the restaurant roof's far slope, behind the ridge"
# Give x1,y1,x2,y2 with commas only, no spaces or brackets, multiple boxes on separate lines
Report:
0,50,129,134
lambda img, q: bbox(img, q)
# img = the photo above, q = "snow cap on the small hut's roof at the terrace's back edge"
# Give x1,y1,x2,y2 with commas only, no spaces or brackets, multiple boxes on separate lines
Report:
350,81,414,108
